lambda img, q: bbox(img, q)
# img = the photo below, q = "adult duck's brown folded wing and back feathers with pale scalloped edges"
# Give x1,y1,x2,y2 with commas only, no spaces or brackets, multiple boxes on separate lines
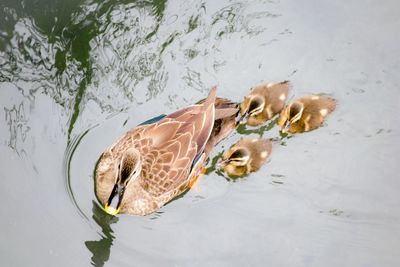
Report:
136,89,219,197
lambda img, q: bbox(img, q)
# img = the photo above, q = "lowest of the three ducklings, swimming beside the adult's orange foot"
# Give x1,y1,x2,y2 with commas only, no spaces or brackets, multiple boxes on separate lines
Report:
218,138,272,176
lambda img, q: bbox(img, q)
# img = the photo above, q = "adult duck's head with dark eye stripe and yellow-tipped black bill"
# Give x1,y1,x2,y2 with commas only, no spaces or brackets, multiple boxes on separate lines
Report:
105,148,142,215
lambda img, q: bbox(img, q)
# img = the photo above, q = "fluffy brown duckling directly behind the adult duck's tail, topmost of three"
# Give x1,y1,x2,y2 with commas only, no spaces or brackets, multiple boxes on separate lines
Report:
240,81,289,126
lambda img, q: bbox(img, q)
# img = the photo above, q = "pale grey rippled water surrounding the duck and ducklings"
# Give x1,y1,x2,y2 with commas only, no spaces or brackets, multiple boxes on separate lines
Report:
0,0,400,266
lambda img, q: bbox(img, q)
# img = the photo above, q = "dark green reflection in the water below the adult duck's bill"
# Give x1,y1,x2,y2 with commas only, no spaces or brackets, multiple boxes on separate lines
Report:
85,201,118,267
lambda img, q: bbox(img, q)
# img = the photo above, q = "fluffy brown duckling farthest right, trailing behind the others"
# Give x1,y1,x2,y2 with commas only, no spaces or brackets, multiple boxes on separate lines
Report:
278,95,336,133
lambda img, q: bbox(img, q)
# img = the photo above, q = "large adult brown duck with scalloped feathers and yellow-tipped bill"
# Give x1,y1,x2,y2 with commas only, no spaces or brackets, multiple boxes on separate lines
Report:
95,87,239,216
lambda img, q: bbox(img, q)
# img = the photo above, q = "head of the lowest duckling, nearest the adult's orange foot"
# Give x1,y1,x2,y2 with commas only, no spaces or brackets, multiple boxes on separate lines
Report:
218,146,250,176
